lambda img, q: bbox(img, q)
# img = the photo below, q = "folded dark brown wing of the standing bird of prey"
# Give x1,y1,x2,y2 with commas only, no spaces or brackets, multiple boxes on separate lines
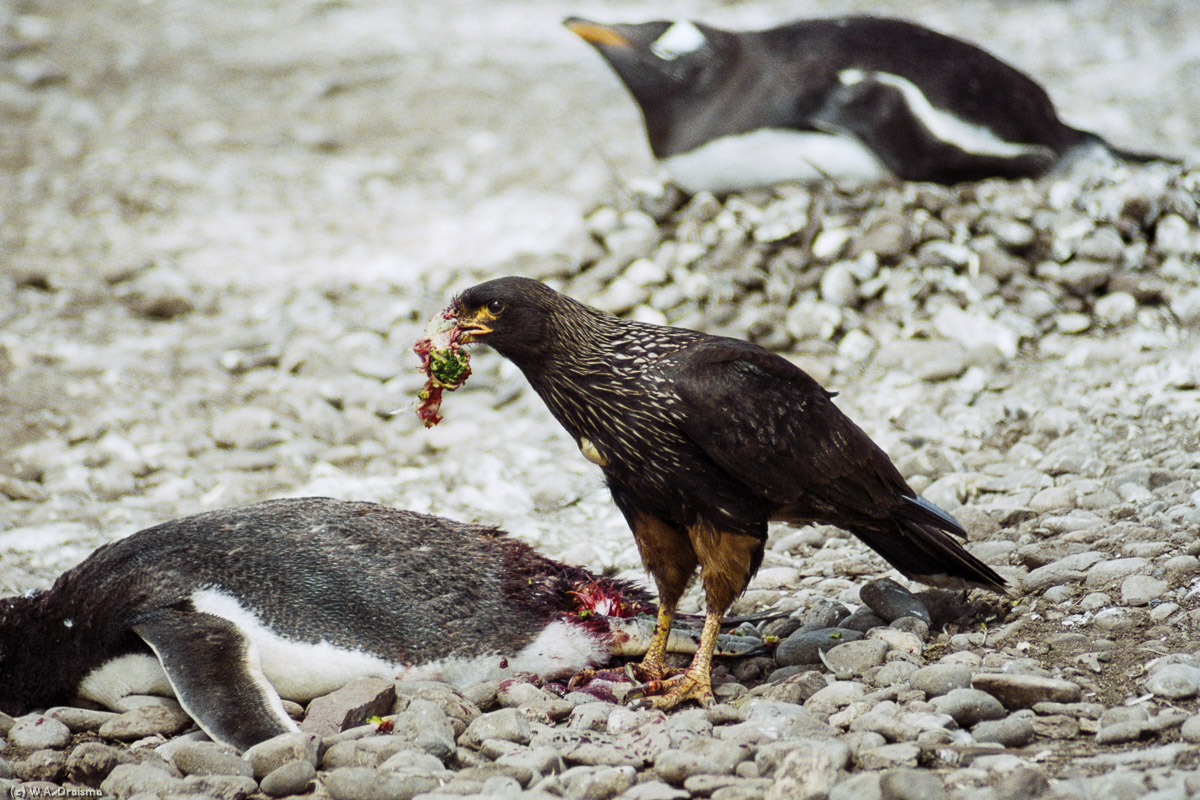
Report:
662,339,910,517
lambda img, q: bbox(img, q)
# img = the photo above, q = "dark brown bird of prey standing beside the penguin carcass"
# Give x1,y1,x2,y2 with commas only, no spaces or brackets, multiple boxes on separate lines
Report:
429,277,1006,708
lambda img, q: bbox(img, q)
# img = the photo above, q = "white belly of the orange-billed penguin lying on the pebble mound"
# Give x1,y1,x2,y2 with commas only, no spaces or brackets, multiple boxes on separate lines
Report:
662,128,888,194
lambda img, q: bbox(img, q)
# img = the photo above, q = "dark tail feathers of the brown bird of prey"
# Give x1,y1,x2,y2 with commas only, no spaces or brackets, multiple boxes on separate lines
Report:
850,518,1008,594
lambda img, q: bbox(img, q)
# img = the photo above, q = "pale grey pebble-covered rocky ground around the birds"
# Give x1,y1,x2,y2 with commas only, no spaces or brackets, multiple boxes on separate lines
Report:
0,0,1200,800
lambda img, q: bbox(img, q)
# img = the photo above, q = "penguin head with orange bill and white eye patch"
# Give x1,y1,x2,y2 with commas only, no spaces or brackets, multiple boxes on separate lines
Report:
563,17,737,157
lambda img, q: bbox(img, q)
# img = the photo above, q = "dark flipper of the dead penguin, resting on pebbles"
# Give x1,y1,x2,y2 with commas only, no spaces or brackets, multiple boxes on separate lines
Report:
132,610,298,751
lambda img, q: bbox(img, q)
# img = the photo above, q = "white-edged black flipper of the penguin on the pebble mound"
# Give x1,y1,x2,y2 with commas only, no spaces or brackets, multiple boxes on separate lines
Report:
811,71,1057,184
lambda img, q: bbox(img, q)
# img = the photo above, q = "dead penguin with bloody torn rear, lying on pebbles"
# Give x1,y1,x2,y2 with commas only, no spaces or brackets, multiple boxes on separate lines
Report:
0,498,749,750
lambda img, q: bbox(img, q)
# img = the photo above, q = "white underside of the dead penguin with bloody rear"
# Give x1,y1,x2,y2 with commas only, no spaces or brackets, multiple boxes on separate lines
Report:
78,589,612,728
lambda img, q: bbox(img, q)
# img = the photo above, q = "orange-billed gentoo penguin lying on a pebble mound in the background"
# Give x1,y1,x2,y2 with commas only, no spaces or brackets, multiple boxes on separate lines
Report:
565,17,1154,192
